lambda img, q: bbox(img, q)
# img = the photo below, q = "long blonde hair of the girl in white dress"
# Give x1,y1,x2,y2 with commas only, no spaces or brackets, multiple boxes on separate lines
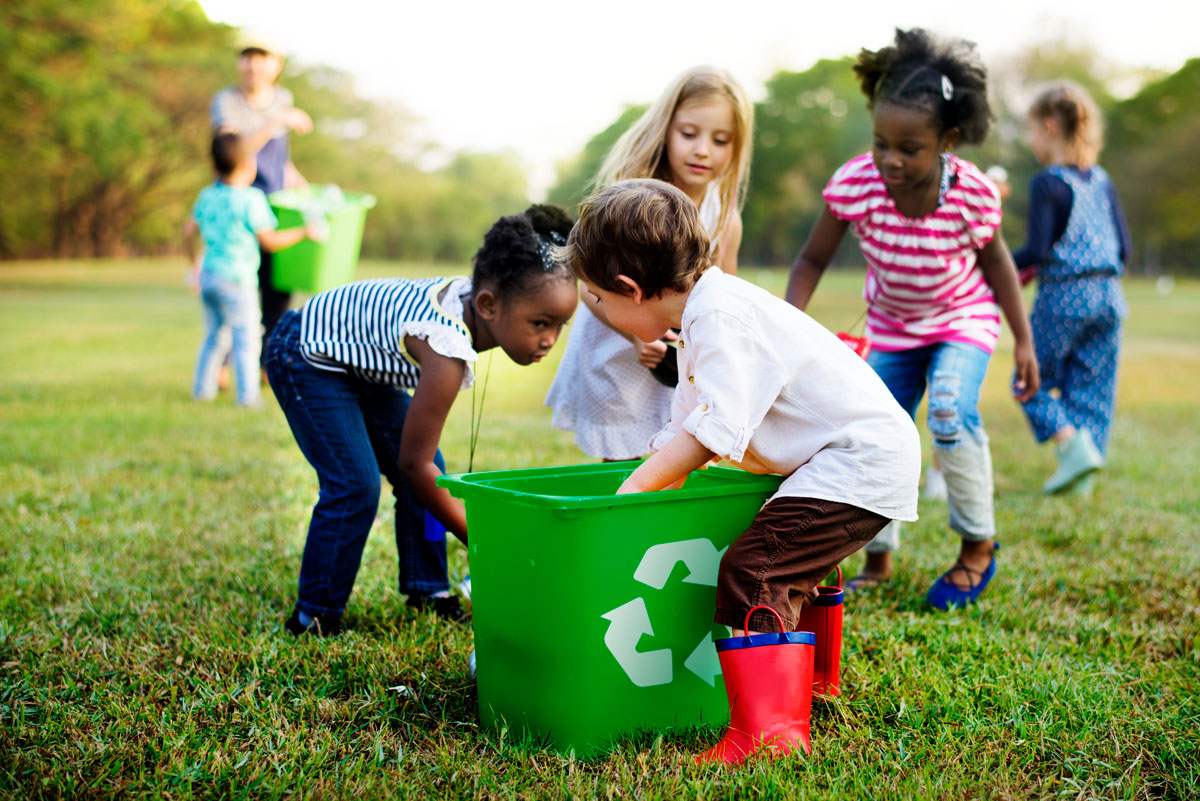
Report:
592,66,754,251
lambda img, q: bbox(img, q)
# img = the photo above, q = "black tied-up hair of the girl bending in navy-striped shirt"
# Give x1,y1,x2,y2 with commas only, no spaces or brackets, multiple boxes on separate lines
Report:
472,204,575,302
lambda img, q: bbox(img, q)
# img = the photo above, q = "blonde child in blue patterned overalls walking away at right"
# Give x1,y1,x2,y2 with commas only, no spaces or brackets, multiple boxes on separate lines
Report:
1013,82,1129,493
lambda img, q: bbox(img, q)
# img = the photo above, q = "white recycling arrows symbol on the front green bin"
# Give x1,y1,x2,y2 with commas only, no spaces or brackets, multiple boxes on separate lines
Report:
600,538,726,687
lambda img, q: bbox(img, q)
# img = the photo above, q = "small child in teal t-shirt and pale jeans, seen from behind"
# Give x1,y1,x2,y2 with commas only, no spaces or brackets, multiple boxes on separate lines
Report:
184,133,317,408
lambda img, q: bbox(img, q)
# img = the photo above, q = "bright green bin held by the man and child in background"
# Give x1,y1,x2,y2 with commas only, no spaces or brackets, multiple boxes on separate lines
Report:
269,186,376,294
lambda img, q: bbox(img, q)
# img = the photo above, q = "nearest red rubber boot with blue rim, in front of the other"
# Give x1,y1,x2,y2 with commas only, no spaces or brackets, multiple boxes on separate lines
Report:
695,607,814,765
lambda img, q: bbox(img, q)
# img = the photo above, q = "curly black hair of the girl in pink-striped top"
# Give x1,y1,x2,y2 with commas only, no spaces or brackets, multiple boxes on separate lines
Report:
854,28,992,145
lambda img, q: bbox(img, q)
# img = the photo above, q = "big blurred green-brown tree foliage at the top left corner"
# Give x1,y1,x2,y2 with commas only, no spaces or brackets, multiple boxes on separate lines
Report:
0,0,233,257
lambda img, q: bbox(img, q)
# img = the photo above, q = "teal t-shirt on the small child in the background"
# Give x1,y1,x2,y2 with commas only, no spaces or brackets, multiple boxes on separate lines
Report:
192,181,278,287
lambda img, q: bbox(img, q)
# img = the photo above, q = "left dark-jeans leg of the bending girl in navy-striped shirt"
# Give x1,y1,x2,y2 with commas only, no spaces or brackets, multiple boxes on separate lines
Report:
266,313,380,618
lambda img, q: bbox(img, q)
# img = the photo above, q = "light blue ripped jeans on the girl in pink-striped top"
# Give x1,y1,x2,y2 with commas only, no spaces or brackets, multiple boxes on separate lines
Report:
866,342,996,553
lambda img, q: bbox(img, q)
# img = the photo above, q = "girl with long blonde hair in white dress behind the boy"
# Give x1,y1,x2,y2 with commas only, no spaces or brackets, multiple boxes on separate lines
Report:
546,66,754,460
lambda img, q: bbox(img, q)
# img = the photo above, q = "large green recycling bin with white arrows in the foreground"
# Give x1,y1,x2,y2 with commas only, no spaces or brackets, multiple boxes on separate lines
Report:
438,462,781,757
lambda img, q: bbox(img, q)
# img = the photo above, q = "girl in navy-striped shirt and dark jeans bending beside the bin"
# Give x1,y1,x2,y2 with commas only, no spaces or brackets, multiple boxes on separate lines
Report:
266,206,578,636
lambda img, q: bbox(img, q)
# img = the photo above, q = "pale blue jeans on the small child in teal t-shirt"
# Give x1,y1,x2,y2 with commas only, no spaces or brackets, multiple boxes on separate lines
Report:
192,270,259,405
